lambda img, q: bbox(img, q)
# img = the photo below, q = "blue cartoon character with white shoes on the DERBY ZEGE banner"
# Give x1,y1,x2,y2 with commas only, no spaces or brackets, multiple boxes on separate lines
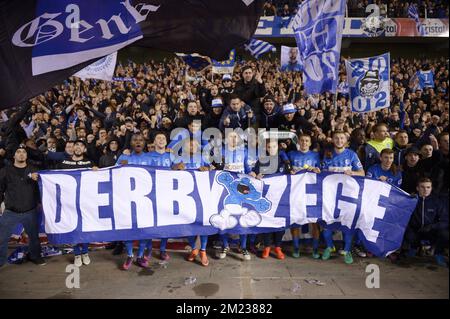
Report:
209,172,272,230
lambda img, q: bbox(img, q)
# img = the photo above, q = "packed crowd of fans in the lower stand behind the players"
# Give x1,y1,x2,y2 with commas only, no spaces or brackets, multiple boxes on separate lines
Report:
0,53,449,270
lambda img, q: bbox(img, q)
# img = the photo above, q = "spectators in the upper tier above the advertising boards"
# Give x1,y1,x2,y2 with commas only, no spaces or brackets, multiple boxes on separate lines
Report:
263,0,449,19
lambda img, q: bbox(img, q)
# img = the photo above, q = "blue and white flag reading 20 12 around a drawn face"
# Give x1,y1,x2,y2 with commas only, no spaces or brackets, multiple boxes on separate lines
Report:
345,53,390,113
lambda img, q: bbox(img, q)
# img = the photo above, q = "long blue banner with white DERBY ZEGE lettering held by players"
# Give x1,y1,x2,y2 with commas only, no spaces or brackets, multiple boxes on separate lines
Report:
39,165,417,256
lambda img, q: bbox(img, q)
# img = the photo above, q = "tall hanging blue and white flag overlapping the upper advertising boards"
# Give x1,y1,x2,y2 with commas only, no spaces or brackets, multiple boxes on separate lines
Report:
292,0,345,94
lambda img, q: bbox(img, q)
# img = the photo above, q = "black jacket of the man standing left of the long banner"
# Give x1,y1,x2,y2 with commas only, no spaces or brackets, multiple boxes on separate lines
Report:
0,165,40,213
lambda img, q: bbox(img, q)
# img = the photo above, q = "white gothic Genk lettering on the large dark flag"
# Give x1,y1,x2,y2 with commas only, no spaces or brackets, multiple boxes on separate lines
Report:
12,0,160,47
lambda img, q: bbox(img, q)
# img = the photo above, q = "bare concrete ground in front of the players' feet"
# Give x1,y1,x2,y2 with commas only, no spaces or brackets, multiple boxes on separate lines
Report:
0,250,449,299
